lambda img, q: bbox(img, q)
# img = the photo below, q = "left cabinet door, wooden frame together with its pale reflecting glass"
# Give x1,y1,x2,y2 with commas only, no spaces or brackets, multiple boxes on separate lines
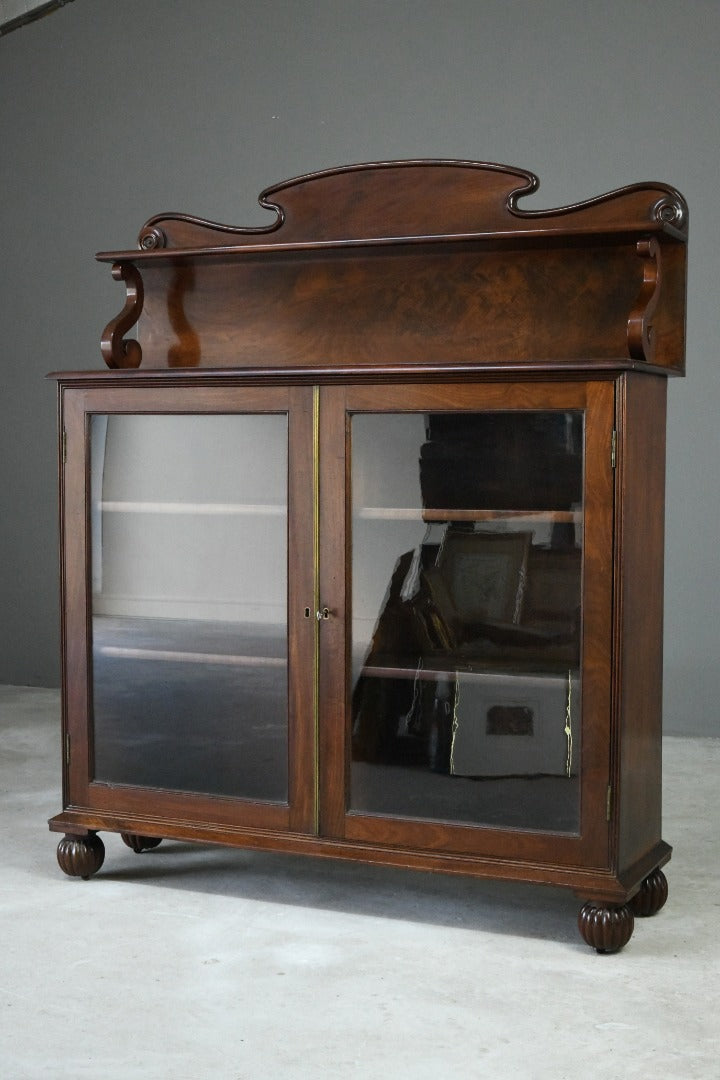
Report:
64,387,315,832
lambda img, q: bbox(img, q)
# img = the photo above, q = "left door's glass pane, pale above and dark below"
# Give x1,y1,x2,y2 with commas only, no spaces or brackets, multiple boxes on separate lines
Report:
91,415,288,802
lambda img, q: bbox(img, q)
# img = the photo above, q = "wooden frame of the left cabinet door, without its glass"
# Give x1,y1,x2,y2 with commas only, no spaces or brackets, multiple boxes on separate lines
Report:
60,375,317,835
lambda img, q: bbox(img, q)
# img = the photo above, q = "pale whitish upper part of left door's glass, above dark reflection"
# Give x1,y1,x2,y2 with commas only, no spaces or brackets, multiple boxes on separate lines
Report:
91,415,287,624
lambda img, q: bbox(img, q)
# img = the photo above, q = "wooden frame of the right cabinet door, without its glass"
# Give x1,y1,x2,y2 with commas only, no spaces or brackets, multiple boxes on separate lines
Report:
320,379,614,868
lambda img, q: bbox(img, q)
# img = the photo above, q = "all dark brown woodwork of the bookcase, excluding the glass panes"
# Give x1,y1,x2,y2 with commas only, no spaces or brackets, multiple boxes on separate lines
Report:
51,161,688,951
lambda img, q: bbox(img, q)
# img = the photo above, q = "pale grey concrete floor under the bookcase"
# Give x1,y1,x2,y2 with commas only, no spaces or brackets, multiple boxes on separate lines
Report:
0,687,720,1080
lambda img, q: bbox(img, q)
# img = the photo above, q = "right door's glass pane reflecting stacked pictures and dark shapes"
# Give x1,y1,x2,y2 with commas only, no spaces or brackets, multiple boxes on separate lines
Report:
350,411,584,833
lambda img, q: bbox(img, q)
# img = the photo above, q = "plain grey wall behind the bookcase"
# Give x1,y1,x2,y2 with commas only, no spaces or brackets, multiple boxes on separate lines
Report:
0,0,720,733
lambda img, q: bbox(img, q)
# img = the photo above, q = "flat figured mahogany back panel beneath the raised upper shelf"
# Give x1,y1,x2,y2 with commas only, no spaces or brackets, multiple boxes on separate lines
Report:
133,244,682,368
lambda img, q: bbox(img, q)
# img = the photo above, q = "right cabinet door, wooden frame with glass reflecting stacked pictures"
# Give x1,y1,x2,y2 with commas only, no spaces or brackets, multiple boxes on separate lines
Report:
320,382,613,866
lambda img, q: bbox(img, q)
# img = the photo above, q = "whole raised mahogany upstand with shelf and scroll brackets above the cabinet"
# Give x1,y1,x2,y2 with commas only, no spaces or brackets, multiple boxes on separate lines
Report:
98,161,688,370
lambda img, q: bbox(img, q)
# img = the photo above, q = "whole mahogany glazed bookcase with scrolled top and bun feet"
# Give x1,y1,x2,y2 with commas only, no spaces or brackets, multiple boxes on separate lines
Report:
50,161,688,951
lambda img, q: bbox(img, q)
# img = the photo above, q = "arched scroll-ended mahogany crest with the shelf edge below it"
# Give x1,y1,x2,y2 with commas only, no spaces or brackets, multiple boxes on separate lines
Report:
98,161,688,261
